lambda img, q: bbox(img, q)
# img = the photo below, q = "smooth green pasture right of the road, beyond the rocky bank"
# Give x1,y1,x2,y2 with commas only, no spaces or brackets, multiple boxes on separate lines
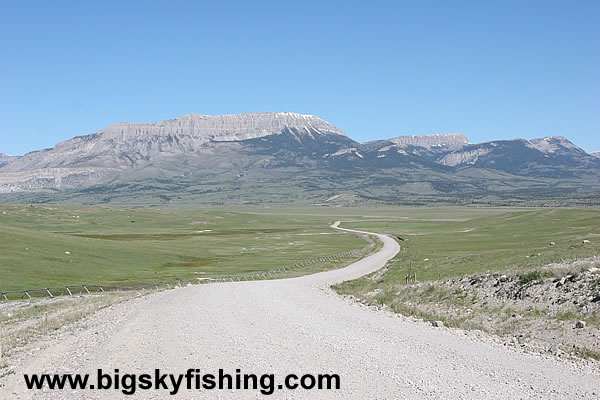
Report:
342,208,600,281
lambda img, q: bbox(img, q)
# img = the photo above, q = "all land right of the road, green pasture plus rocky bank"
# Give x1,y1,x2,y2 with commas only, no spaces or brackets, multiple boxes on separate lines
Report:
334,208,600,359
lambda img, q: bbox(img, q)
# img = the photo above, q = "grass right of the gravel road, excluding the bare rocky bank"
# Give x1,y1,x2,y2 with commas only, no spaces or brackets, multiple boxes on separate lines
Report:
334,208,600,359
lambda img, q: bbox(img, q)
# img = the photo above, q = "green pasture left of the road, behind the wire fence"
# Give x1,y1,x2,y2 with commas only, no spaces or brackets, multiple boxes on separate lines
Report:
0,205,366,290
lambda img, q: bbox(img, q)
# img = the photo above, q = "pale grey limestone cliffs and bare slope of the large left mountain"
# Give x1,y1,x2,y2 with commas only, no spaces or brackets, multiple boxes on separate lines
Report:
0,112,346,193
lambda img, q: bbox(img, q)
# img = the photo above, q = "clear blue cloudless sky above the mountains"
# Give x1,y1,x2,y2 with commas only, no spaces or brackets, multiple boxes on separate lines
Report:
0,0,600,154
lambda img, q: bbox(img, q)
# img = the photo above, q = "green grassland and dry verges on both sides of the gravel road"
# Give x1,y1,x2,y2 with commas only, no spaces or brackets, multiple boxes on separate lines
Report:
0,205,600,364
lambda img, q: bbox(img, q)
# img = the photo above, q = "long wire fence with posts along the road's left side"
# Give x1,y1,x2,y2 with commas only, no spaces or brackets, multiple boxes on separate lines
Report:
0,236,375,301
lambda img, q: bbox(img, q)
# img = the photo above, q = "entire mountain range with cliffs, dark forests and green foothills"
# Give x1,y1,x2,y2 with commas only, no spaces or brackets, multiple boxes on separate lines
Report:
0,112,600,204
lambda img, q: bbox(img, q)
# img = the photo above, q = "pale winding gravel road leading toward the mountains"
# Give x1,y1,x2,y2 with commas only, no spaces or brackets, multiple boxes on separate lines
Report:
0,223,600,399
